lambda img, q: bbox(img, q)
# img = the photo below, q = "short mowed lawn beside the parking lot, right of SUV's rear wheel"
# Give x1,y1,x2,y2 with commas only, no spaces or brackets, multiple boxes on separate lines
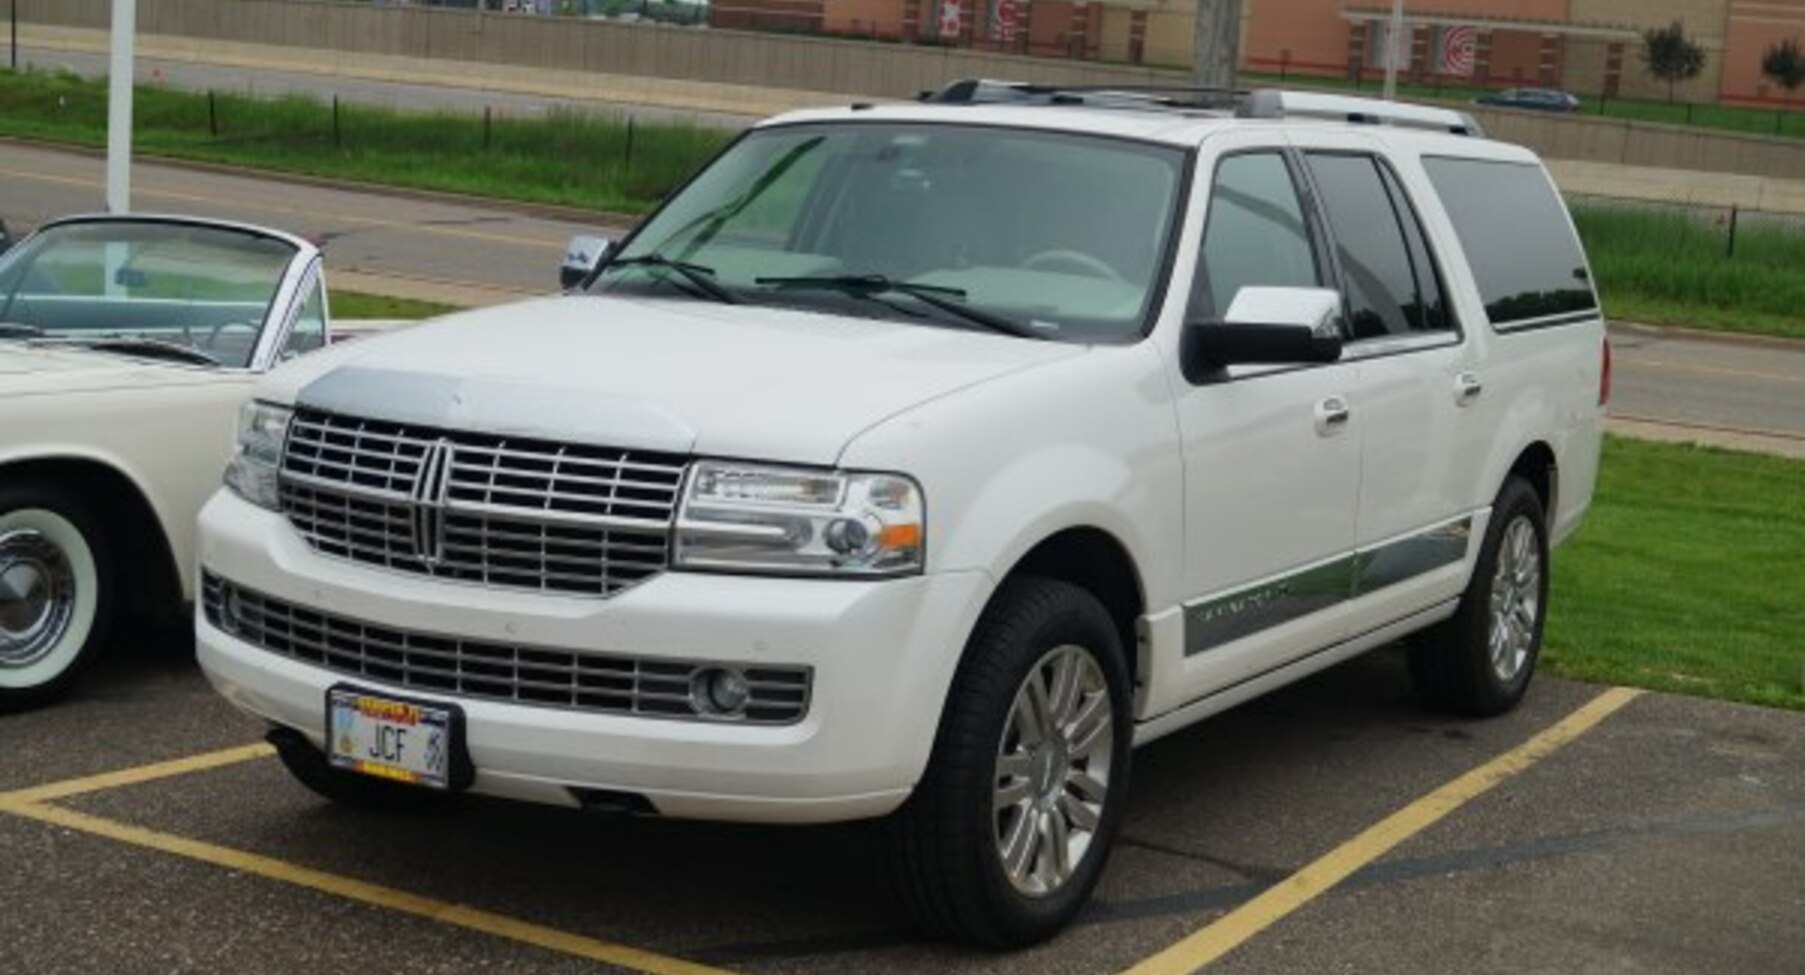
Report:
1543,439,1805,710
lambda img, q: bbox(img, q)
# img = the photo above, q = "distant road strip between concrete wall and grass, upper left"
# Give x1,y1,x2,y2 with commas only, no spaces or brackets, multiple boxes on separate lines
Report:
8,47,756,132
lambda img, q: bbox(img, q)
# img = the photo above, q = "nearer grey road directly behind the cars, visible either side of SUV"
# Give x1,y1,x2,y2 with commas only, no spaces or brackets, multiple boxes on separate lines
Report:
0,143,1805,457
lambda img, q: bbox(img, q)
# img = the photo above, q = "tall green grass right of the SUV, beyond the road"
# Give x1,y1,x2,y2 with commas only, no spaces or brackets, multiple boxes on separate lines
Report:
1572,202,1805,338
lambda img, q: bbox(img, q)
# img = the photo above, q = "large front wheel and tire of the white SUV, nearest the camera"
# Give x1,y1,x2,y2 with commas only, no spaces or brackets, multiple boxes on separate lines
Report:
884,578,1134,948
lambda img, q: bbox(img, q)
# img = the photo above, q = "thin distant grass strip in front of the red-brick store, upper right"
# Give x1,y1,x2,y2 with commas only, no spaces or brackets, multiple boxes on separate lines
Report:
1242,72,1805,139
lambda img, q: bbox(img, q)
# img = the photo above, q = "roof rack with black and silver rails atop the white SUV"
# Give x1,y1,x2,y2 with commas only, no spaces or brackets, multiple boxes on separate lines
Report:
917,78,1486,139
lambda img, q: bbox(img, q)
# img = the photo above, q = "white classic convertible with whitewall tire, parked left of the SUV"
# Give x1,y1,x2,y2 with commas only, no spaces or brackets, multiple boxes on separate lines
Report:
0,215,329,710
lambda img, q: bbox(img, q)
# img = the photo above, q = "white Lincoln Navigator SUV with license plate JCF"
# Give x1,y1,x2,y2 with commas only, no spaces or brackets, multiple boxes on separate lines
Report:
197,83,1610,944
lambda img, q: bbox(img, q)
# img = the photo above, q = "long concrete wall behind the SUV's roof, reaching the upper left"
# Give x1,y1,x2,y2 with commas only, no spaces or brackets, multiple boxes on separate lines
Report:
18,0,1177,98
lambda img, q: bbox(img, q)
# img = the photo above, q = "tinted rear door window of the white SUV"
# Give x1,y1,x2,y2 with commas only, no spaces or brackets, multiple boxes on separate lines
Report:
1309,153,1430,339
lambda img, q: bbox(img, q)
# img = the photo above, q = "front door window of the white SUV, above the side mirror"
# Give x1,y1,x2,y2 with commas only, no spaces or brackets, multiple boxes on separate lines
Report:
1189,152,1321,320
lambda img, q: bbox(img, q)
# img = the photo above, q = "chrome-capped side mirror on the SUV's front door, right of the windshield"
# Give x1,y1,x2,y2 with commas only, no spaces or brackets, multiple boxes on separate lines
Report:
1179,287,1341,383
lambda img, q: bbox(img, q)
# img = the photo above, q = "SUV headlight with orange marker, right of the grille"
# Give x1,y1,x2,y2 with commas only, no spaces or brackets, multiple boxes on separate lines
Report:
673,460,924,578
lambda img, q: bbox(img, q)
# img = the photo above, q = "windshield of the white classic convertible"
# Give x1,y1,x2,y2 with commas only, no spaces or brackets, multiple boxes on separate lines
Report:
0,220,296,368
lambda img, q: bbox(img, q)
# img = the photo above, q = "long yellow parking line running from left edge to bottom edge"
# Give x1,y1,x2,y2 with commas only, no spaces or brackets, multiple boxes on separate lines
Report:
0,793,731,975
